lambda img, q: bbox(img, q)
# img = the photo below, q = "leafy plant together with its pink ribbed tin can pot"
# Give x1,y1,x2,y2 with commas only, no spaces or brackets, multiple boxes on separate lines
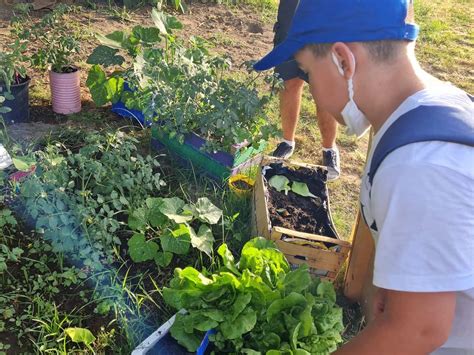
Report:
30,5,81,115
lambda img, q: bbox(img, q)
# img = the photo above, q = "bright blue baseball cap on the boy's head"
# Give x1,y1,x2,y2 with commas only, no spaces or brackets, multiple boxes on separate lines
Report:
254,0,420,70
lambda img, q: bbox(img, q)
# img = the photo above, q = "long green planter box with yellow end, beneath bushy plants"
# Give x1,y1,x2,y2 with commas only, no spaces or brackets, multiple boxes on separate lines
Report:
151,125,267,181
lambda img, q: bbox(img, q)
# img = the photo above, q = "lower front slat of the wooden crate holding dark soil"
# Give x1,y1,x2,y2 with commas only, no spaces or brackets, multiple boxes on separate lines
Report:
275,240,345,272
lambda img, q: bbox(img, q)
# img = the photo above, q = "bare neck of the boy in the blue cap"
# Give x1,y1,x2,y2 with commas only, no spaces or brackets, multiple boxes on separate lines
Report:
360,56,432,132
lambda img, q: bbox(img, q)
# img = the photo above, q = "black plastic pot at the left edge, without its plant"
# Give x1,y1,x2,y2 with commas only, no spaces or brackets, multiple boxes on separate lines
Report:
0,77,30,124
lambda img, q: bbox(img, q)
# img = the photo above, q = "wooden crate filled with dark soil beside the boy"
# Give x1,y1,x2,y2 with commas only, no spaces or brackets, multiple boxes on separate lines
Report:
252,157,351,281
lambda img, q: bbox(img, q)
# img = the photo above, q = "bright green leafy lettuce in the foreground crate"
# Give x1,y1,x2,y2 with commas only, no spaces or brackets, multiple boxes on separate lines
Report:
163,238,344,355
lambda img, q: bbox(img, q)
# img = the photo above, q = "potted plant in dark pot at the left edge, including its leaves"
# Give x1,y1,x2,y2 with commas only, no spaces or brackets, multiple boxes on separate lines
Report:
0,40,30,123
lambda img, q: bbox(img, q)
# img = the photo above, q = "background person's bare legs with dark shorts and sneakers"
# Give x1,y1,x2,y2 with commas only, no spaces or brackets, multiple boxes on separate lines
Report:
272,0,341,180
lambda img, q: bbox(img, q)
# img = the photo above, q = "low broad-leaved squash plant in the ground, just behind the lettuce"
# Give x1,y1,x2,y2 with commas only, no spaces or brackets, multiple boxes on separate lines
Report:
128,197,222,267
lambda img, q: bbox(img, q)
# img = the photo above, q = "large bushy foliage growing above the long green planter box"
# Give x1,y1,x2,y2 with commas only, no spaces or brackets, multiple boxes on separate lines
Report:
87,9,277,151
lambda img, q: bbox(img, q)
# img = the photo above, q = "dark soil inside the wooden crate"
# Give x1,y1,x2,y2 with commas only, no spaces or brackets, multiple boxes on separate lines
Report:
264,163,337,238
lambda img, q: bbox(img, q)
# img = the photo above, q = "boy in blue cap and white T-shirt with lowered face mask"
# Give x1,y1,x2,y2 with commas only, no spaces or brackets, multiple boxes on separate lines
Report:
255,0,474,355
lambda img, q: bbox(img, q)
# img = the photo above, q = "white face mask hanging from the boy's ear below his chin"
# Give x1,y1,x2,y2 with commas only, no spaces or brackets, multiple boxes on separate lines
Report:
331,53,370,137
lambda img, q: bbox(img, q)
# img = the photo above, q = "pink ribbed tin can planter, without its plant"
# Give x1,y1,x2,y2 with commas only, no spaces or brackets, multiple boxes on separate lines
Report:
49,67,81,115
